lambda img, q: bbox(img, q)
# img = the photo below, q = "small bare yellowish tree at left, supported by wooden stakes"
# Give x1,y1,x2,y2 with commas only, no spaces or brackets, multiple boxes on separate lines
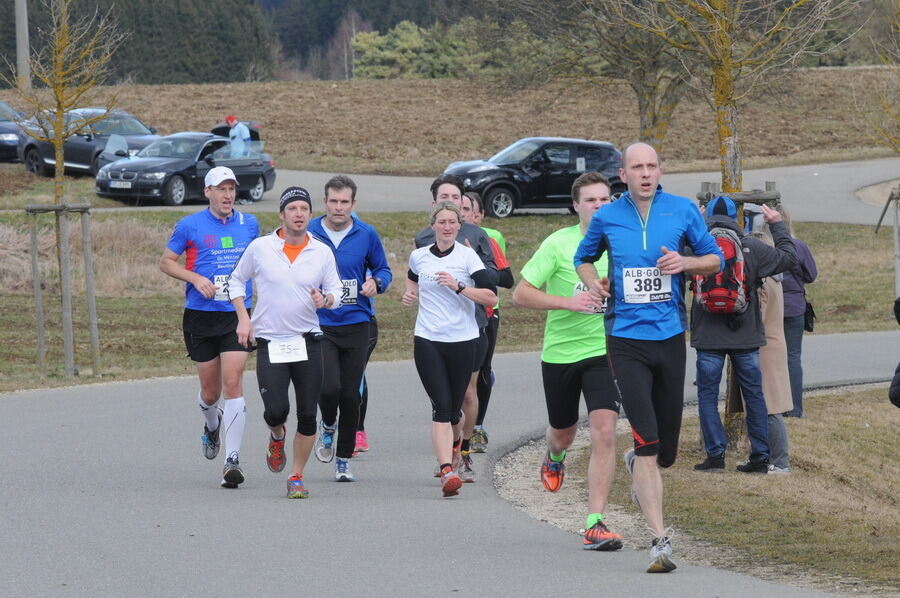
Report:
3,0,125,204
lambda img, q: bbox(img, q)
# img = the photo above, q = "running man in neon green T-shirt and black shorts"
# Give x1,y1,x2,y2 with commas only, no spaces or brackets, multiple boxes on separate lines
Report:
513,172,622,550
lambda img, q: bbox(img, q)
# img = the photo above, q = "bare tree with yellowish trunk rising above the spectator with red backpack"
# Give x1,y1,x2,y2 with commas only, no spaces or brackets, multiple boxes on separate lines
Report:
614,0,859,192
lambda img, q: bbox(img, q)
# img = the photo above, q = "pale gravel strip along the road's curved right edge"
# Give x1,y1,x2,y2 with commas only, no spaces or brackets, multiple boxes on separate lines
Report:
494,384,898,597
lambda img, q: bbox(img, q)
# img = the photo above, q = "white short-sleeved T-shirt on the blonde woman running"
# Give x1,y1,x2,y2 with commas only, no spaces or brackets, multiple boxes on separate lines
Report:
409,242,484,343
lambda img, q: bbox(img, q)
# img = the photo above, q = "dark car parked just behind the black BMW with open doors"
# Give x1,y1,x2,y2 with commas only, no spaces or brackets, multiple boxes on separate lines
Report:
18,108,159,176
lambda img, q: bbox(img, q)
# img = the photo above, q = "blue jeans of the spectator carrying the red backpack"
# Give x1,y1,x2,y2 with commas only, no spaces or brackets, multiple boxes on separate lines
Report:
697,350,769,463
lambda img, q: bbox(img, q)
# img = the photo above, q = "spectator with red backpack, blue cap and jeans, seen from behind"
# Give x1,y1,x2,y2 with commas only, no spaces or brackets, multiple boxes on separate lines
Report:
691,197,797,473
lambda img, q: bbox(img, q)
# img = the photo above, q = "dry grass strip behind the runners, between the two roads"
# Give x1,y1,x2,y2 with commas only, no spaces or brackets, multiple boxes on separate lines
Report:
0,211,896,391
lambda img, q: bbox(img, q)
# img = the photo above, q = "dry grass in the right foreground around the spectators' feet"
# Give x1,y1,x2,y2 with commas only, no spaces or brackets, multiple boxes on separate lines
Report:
596,387,900,591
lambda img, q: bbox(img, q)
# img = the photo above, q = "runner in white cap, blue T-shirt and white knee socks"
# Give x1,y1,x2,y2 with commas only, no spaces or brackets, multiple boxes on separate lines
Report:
159,166,259,488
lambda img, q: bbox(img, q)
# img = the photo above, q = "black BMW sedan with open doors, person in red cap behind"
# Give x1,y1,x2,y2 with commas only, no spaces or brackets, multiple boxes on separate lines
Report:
96,133,275,206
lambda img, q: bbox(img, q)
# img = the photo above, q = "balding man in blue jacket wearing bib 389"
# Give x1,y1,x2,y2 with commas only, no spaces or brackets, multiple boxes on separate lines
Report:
574,143,724,573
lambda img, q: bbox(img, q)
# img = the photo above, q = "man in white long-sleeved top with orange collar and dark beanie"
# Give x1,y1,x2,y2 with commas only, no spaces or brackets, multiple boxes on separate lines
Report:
228,187,343,498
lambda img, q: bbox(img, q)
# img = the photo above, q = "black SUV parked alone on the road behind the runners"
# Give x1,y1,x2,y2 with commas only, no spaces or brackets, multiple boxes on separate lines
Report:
444,137,625,218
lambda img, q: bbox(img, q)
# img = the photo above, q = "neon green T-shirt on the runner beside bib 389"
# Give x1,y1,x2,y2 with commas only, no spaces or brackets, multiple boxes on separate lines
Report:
522,224,608,363
